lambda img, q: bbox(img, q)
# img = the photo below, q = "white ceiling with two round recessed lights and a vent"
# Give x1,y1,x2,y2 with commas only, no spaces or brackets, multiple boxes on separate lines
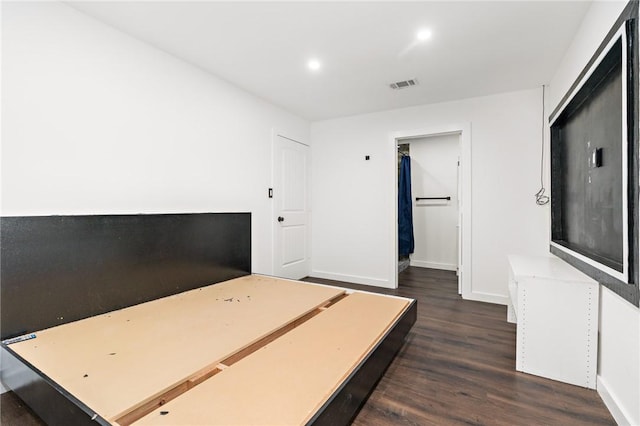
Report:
68,1,590,121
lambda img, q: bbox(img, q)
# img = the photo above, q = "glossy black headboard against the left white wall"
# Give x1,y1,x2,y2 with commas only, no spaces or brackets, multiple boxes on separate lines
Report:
0,213,251,339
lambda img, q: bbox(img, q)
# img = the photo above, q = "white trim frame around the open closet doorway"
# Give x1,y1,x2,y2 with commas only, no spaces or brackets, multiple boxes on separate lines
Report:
387,123,473,299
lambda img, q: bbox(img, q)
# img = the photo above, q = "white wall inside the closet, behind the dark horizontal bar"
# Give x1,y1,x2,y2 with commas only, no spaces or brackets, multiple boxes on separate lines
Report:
409,135,460,271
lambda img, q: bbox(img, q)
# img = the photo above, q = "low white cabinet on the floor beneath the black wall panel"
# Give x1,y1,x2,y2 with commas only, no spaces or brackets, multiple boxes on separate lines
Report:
507,256,599,389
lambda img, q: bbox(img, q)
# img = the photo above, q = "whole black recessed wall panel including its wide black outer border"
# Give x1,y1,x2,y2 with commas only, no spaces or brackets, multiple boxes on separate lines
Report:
549,1,640,306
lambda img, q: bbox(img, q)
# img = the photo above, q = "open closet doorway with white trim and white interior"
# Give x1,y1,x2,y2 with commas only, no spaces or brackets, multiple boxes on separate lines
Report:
393,124,471,297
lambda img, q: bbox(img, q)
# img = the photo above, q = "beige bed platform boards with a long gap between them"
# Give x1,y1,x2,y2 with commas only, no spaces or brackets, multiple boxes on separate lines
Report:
10,275,410,426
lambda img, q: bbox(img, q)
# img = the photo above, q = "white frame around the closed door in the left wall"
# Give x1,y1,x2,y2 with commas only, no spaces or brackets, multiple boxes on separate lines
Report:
269,128,312,276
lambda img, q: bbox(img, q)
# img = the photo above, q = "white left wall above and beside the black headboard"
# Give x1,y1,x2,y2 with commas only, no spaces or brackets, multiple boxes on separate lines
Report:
2,2,309,273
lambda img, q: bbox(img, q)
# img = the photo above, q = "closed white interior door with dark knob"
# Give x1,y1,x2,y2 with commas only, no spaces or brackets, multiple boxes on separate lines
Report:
273,135,310,279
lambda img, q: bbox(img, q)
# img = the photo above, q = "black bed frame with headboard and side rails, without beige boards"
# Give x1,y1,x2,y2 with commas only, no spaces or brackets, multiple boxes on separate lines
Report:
0,213,417,425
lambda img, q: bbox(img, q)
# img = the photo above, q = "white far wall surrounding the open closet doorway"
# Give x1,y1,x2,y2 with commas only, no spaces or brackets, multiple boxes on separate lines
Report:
311,89,548,303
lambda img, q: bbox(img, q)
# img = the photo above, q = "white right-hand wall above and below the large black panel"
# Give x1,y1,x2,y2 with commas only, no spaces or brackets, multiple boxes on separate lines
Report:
549,2,640,425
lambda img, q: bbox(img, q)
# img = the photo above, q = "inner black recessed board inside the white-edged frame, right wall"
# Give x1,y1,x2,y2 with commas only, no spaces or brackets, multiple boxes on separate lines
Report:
552,40,626,272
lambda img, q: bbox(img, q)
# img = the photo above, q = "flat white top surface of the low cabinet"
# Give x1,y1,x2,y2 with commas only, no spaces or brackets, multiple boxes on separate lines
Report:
508,255,597,284
